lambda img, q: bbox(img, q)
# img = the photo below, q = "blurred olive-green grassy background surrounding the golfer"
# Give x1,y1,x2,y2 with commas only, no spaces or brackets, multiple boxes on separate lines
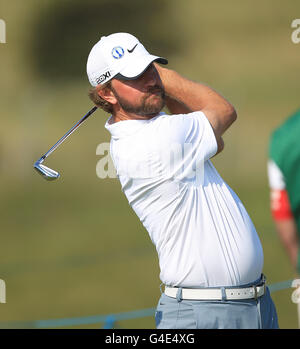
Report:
0,0,300,328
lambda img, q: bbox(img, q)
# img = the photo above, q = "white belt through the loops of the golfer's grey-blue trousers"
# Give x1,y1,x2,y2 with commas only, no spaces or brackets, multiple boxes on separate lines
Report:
165,284,266,301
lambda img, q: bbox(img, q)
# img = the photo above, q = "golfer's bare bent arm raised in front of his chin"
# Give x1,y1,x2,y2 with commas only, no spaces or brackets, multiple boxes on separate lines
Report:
156,65,236,139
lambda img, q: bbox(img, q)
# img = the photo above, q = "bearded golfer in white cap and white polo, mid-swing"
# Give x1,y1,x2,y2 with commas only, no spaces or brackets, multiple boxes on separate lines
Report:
87,33,278,329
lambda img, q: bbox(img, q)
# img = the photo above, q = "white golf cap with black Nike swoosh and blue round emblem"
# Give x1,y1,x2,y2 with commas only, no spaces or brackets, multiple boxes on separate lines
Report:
86,33,168,86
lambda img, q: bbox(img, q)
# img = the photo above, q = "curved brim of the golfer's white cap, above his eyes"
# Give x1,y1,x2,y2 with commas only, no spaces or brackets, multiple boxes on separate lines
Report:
114,55,168,80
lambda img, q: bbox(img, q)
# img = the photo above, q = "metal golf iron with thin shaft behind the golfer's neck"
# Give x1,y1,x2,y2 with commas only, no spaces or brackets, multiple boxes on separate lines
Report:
34,107,97,181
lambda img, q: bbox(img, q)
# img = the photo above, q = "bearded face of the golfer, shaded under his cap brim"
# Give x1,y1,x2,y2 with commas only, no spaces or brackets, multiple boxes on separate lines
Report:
111,64,165,119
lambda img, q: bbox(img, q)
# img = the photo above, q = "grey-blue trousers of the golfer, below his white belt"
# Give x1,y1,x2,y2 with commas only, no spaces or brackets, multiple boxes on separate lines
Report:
155,288,279,329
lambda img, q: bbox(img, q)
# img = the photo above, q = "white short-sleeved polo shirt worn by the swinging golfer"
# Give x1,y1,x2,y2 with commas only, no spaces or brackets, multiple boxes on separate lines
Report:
105,112,263,287
